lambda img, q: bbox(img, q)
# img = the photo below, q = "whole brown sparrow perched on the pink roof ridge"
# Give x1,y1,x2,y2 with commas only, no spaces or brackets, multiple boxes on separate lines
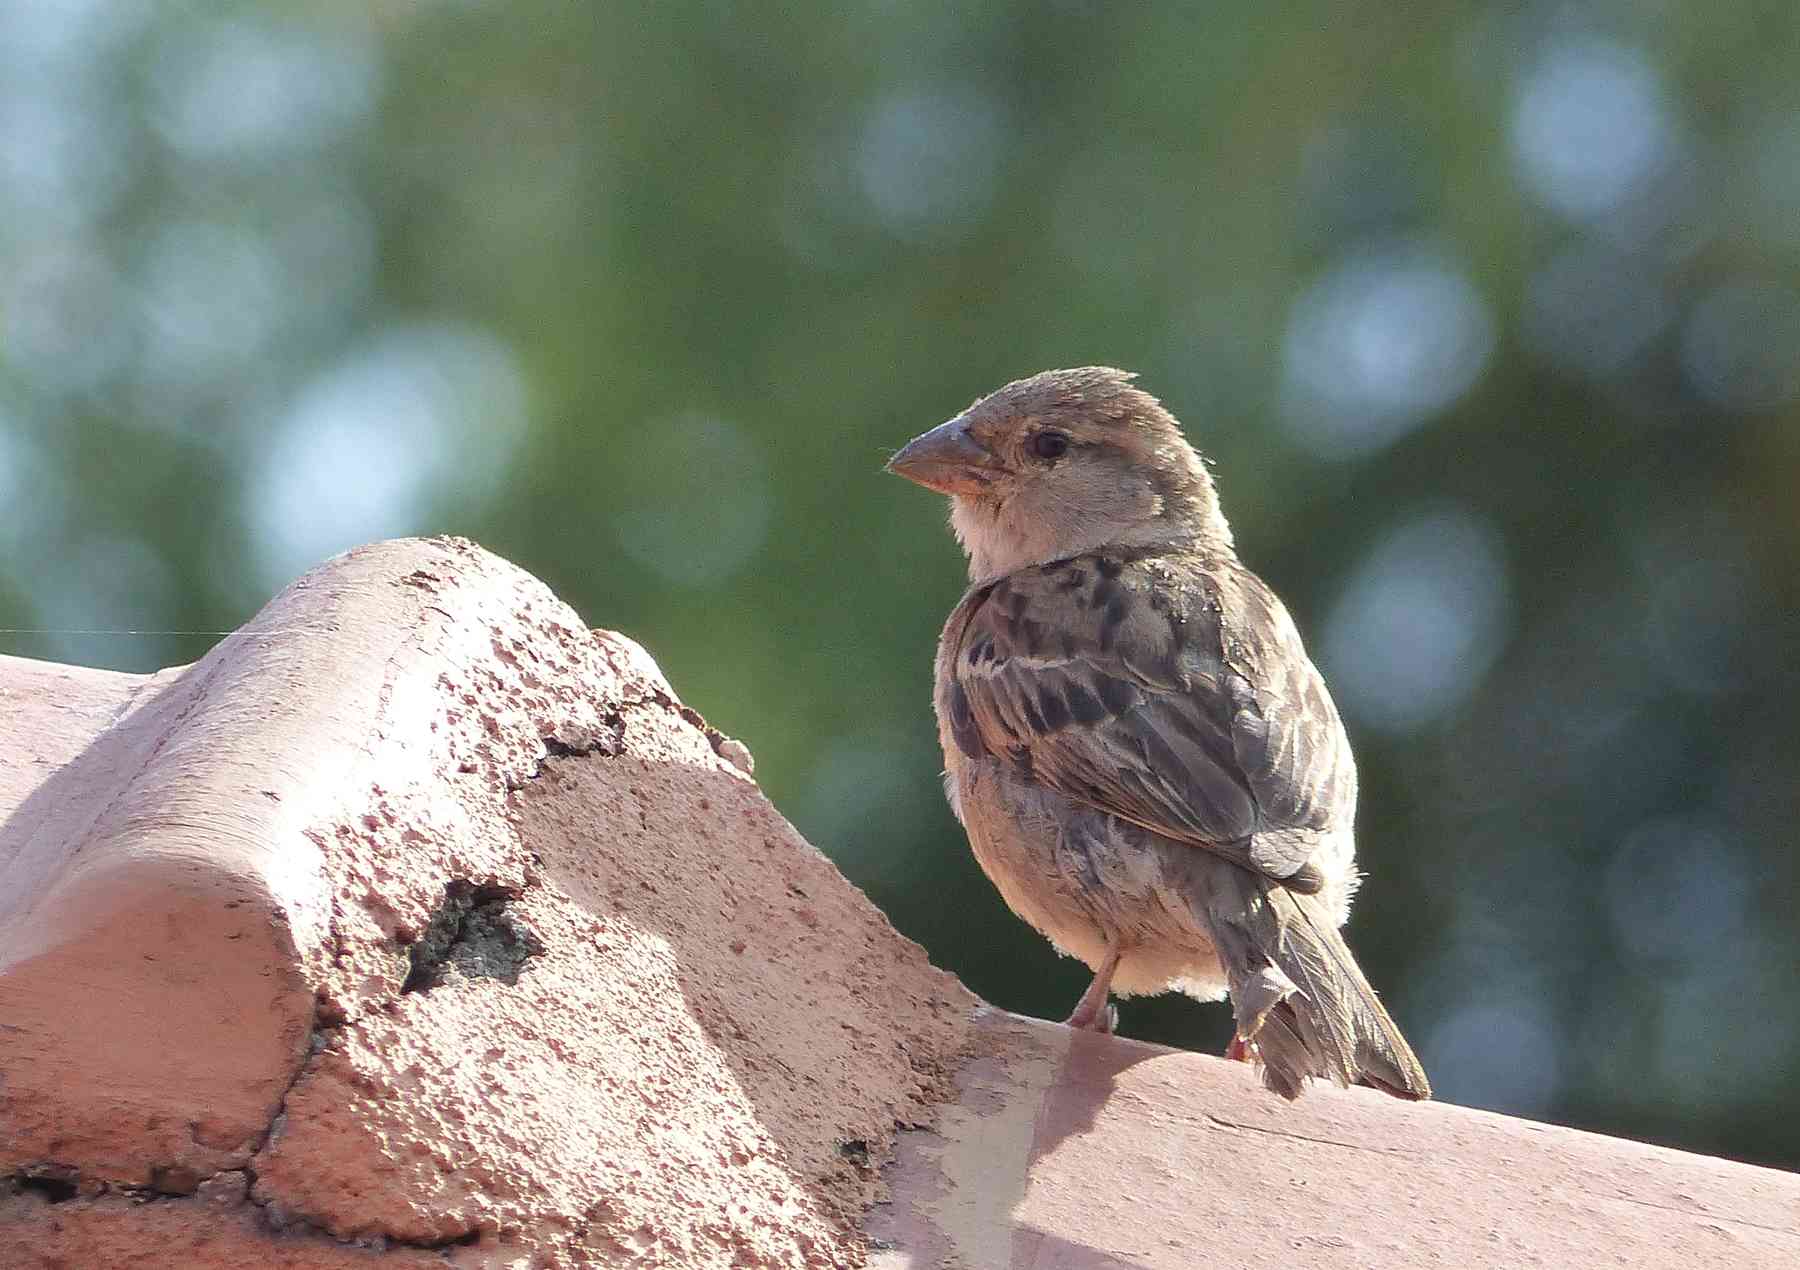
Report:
887,367,1431,1099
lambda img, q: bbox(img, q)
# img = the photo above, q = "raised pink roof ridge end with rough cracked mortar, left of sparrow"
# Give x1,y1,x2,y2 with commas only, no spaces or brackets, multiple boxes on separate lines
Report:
0,540,976,1270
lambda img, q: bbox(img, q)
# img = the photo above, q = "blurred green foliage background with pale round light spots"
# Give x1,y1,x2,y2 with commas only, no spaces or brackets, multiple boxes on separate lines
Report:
0,0,1800,1166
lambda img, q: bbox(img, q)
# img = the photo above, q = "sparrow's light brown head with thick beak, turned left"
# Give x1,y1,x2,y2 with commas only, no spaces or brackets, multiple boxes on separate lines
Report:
887,367,1231,581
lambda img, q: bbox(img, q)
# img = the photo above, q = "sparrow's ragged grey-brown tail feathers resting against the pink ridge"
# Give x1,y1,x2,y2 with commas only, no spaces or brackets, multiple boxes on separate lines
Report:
1202,862,1431,1099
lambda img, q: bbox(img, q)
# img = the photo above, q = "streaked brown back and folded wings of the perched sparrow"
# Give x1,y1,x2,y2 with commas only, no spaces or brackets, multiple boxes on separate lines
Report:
938,554,1355,890
